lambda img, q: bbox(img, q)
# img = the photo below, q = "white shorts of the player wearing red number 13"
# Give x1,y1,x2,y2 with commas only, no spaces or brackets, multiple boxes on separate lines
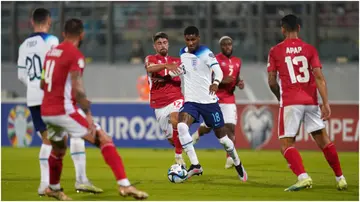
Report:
278,105,325,138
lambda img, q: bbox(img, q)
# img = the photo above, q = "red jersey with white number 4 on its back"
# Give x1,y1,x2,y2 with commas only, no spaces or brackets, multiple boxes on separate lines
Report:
41,42,85,116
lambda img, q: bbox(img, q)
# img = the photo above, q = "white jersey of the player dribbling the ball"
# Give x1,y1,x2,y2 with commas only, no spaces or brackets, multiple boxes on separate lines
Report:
180,46,218,104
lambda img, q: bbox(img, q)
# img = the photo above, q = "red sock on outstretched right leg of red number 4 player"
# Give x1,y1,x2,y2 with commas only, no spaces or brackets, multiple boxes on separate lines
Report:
101,143,127,180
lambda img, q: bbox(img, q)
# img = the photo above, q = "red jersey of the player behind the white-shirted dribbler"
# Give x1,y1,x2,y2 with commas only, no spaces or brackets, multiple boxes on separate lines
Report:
216,53,241,104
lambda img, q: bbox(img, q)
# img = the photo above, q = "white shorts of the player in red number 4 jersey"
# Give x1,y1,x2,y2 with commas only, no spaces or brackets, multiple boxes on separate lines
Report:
42,109,100,141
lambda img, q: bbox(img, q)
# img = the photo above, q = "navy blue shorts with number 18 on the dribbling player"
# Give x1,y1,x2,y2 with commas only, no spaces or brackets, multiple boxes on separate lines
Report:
180,102,224,128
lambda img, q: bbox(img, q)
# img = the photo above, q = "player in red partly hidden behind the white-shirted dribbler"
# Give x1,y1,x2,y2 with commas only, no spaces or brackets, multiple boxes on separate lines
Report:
192,36,244,168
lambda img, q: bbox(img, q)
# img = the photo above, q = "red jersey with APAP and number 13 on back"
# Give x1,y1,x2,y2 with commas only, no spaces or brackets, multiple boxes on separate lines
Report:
267,39,321,107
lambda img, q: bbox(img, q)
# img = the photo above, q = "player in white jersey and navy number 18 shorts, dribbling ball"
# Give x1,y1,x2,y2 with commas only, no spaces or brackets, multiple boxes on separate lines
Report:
178,26,247,181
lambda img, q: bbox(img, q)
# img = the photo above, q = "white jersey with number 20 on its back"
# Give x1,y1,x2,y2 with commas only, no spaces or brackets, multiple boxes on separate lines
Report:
17,32,59,107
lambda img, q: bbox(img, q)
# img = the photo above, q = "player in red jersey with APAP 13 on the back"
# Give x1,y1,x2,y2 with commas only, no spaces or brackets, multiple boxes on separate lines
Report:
267,15,347,191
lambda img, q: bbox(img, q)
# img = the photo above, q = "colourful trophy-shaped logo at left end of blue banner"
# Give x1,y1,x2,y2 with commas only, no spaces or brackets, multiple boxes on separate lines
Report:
7,105,34,147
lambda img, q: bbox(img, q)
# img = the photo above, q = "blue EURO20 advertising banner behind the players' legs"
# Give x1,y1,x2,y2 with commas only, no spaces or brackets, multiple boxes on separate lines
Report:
1,102,222,148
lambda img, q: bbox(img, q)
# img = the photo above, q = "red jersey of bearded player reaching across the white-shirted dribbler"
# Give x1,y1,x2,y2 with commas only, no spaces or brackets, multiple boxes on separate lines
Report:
145,54,184,109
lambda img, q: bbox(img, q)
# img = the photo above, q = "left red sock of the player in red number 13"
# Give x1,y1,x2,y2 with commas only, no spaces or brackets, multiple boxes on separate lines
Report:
283,147,305,176
